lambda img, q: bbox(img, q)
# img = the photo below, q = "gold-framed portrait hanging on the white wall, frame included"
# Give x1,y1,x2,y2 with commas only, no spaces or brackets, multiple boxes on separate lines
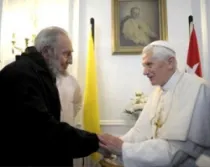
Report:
112,0,167,55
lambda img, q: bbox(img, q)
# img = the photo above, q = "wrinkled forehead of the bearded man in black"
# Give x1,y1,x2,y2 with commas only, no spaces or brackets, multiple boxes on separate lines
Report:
57,35,73,52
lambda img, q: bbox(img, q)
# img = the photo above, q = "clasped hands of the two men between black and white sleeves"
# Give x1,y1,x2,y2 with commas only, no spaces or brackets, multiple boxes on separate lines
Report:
98,134,123,158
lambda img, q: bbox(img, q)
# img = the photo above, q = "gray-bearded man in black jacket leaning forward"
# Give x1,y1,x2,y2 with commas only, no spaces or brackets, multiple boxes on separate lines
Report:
0,27,102,166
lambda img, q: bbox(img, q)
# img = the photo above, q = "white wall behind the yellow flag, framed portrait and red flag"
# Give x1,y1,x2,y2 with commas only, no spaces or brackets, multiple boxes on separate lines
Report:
73,0,209,134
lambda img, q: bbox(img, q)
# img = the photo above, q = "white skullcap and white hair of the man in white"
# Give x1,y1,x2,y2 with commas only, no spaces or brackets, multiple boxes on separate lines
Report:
142,41,176,60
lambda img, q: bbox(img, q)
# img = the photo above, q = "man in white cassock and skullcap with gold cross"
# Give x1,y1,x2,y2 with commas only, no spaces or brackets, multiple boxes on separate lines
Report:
100,41,210,167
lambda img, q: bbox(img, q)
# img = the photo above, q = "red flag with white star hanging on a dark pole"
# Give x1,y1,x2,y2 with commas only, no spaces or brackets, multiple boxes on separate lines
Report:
187,23,202,77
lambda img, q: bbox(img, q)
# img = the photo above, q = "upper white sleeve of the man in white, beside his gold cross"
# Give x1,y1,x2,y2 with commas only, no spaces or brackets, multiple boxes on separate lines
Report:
120,101,152,142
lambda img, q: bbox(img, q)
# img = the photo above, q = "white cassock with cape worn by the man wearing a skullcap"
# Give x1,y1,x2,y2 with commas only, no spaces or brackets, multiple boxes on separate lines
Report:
121,71,210,167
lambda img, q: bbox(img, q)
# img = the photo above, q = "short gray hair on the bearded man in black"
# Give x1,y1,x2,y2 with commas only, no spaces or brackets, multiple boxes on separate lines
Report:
34,26,68,52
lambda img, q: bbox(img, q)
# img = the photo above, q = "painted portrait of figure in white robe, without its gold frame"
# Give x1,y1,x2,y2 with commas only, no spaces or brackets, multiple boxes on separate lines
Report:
120,1,160,47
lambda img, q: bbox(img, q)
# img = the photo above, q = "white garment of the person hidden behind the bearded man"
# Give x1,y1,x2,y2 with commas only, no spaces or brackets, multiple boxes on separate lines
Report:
56,75,82,126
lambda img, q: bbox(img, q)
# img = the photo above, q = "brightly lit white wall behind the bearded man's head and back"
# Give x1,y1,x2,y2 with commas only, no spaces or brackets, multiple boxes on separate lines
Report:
0,0,72,67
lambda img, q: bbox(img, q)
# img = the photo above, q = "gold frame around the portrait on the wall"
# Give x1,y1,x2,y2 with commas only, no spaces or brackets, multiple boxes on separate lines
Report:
112,0,168,55
